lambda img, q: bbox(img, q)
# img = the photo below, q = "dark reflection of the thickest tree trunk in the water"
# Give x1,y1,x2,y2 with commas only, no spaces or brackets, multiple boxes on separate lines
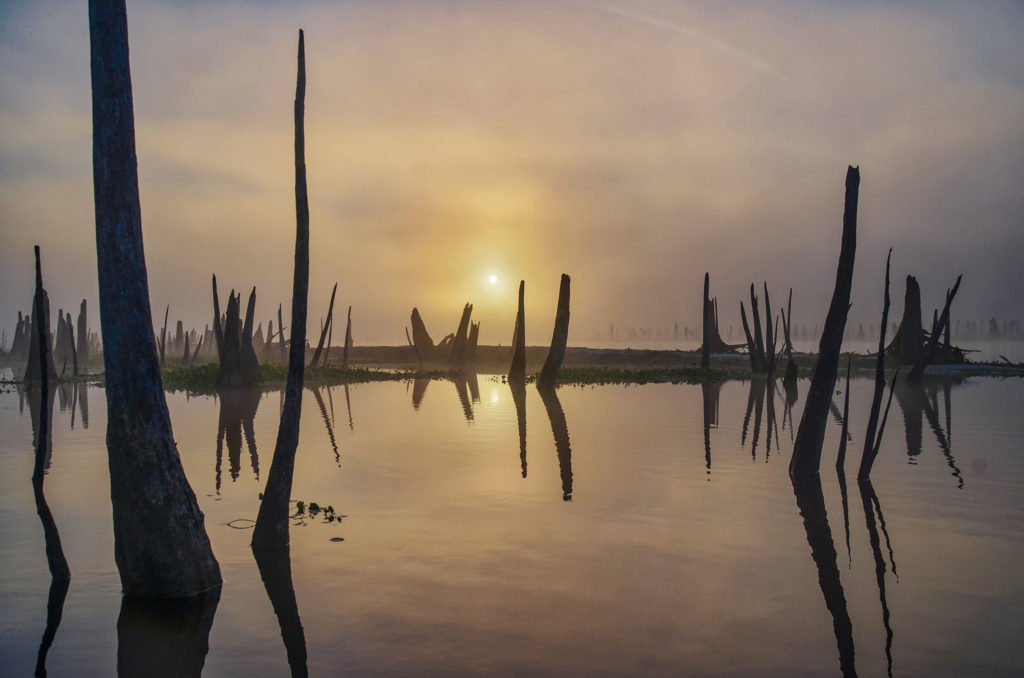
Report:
118,587,220,678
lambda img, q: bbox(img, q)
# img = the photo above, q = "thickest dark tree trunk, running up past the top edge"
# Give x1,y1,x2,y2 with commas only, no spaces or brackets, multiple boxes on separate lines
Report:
89,0,221,598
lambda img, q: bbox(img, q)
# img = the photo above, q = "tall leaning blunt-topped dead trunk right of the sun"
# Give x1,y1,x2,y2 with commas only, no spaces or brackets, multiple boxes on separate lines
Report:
790,166,860,475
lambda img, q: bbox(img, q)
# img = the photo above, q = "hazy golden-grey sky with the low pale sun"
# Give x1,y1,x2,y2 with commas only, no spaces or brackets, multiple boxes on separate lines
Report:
0,0,1024,345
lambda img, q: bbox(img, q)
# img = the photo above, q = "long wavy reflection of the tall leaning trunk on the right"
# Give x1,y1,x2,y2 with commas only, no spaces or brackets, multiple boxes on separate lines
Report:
793,473,857,678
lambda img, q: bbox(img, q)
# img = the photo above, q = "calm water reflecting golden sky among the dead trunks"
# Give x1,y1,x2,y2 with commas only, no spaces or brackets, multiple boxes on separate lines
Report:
0,376,1024,676
